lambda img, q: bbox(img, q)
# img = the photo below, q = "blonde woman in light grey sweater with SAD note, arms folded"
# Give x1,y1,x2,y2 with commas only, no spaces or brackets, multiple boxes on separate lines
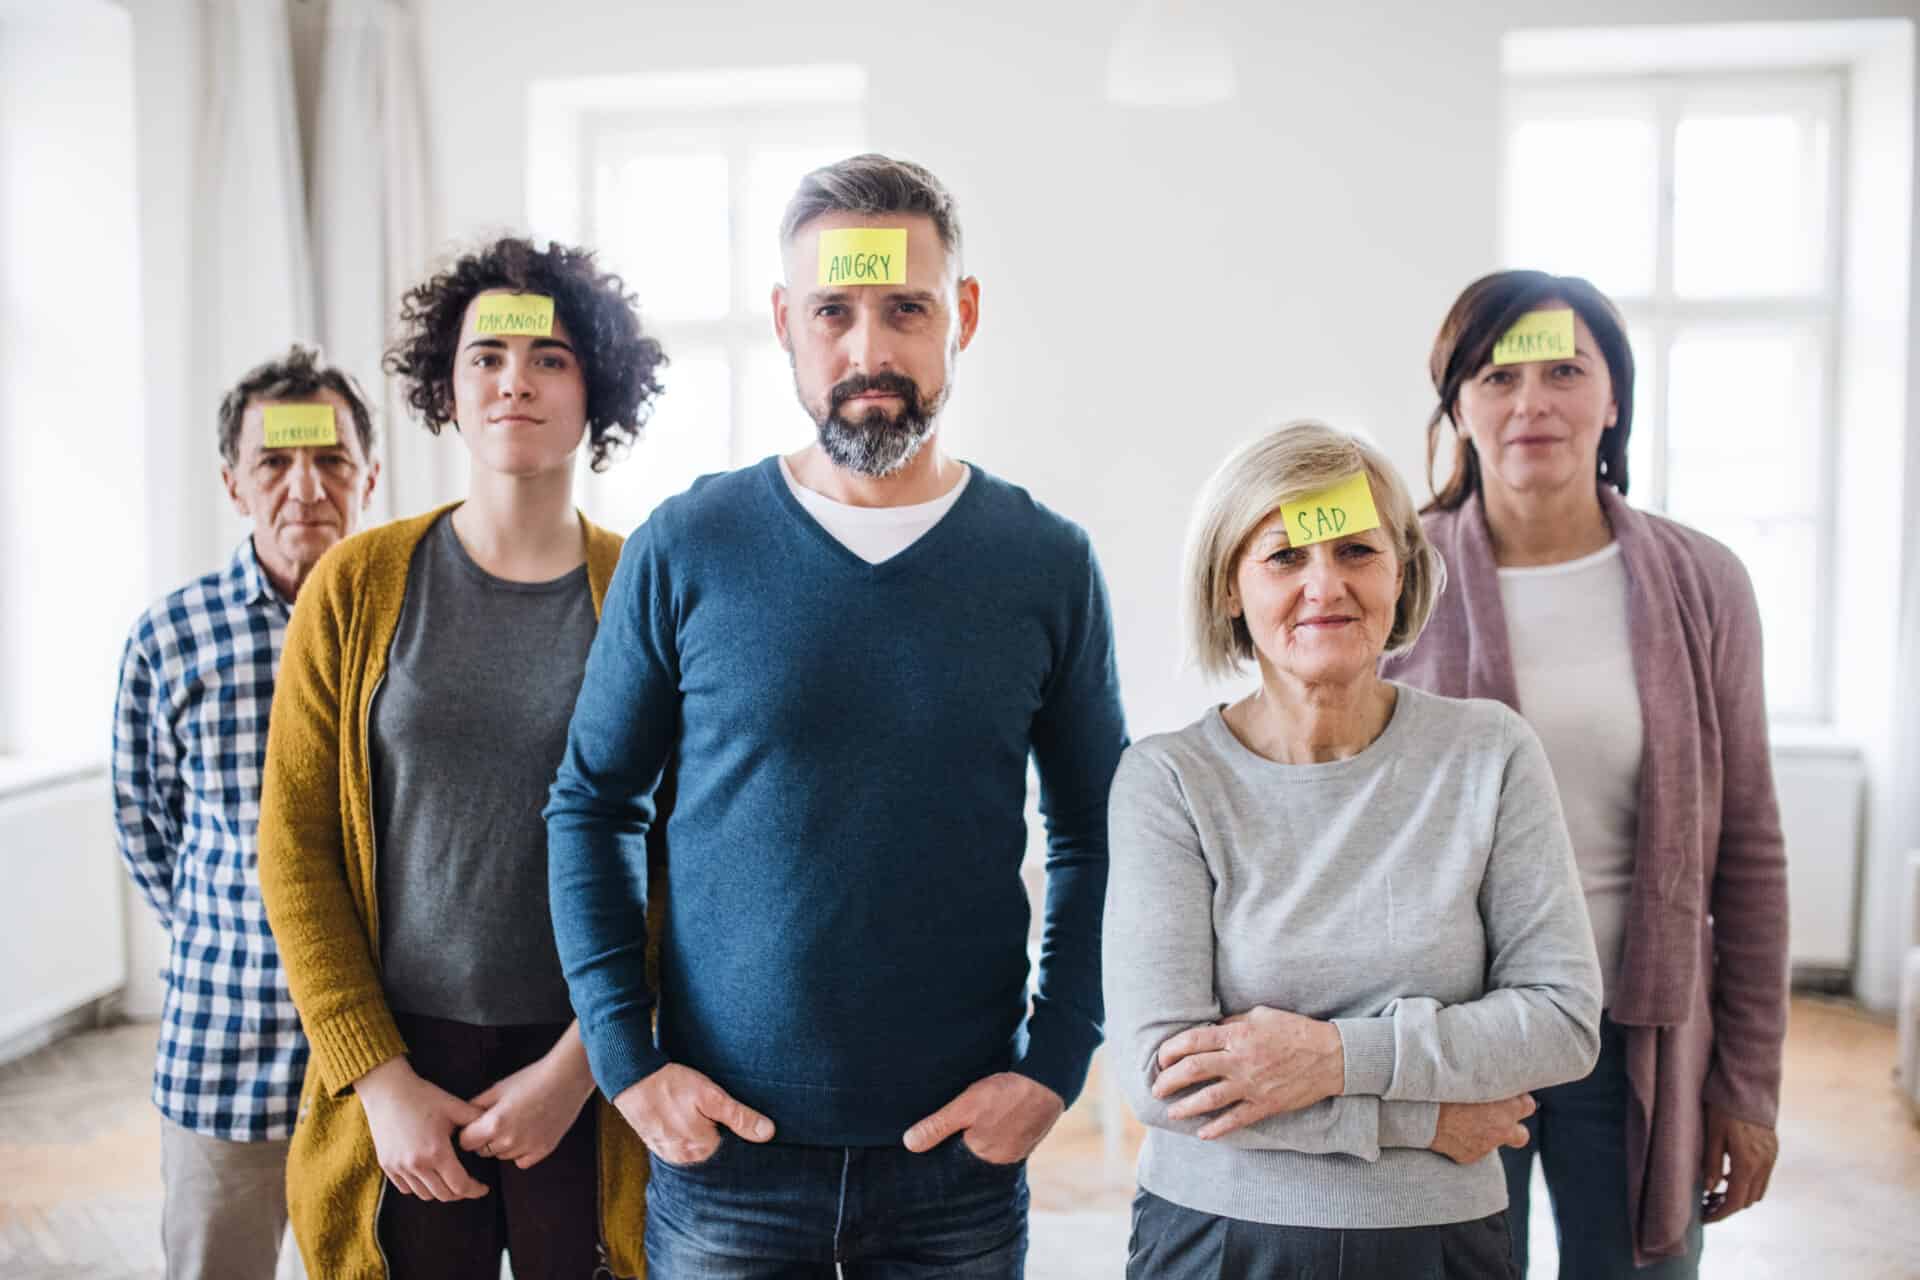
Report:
1104,422,1599,1280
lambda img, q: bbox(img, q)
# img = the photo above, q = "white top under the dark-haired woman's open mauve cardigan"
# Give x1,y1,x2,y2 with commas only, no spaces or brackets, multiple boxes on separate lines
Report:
1500,543,1642,1002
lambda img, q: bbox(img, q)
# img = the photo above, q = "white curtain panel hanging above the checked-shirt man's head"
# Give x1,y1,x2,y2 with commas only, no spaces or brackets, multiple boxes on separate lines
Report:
194,0,317,416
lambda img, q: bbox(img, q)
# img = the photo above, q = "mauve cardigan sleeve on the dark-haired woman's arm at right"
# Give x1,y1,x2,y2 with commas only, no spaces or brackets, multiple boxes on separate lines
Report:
1703,557,1788,1128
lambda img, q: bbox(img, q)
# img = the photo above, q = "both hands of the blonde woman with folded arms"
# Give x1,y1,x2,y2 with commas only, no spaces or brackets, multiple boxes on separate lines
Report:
1152,1006,1534,1165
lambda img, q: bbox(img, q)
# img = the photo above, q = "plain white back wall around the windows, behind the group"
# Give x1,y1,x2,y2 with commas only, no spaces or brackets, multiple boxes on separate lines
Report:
105,0,1920,1004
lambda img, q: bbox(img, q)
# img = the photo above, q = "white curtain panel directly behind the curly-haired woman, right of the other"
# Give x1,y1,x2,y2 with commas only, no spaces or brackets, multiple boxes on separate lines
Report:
309,0,439,518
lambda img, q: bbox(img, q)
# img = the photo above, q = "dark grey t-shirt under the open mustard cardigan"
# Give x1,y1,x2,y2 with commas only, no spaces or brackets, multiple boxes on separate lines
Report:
369,516,597,1027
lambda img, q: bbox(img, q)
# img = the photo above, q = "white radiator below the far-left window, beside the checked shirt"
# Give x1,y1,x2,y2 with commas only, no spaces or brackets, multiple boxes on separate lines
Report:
0,768,127,1044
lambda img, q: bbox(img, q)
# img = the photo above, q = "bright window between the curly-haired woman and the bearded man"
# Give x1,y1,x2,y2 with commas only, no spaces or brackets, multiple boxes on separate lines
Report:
536,69,864,532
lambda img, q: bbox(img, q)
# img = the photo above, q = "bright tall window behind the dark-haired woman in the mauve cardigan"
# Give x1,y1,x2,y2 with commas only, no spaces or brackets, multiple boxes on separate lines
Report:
1501,73,1845,720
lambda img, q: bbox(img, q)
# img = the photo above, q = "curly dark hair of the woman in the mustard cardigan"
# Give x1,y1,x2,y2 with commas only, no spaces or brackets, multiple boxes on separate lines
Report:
386,236,666,472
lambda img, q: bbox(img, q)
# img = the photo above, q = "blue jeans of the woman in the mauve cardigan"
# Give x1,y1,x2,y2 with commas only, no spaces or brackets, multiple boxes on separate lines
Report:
1500,1017,1701,1280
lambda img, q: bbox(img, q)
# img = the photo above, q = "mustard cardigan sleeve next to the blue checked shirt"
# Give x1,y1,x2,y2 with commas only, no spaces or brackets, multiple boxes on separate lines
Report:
259,553,407,1096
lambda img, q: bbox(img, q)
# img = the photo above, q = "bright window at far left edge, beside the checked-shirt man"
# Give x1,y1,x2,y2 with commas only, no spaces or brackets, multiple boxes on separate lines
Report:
0,0,145,764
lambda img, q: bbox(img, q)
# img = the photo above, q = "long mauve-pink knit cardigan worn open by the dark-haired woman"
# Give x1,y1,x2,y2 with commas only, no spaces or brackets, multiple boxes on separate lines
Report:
1382,486,1788,1265
